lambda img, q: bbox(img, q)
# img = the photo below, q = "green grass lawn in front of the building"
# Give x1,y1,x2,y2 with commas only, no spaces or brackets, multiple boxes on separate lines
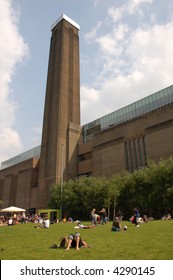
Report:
0,221,173,260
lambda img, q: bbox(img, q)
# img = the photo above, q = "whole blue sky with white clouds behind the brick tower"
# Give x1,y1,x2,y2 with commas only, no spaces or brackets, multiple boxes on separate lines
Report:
0,0,173,165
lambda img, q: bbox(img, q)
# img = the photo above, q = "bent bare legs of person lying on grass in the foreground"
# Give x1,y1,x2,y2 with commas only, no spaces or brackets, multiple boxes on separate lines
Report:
66,232,88,250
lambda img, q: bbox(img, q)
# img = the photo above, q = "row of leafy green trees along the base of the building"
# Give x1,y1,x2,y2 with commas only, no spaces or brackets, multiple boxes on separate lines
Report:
49,157,173,219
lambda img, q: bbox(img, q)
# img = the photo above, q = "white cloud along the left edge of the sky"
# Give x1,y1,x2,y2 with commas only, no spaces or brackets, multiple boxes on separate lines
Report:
0,0,28,162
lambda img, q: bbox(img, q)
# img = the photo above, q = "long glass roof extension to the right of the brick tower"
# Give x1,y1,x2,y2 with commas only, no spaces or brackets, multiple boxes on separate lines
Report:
83,85,173,142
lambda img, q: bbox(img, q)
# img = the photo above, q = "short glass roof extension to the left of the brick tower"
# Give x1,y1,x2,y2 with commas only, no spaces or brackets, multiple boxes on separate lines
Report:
1,146,41,169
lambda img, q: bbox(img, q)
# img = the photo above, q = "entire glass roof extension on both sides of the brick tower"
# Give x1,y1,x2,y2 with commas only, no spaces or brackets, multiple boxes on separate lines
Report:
1,85,173,169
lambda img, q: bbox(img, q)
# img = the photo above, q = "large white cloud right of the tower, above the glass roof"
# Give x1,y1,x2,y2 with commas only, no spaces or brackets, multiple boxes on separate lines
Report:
81,0,173,123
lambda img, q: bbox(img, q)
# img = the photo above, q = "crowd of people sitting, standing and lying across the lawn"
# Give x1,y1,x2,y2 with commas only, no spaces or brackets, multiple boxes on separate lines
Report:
0,208,172,250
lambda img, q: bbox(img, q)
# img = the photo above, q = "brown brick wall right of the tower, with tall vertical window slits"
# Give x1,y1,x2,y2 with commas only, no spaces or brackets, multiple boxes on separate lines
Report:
78,104,173,176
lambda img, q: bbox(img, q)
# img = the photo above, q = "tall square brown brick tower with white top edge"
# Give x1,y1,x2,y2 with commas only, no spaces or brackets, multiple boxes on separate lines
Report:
38,14,81,208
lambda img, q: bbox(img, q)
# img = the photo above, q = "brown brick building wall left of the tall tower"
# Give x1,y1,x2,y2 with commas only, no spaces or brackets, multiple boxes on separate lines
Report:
0,159,39,209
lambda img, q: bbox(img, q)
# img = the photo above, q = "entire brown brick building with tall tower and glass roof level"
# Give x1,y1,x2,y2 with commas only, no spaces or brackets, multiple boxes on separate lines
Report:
0,14,173,210
